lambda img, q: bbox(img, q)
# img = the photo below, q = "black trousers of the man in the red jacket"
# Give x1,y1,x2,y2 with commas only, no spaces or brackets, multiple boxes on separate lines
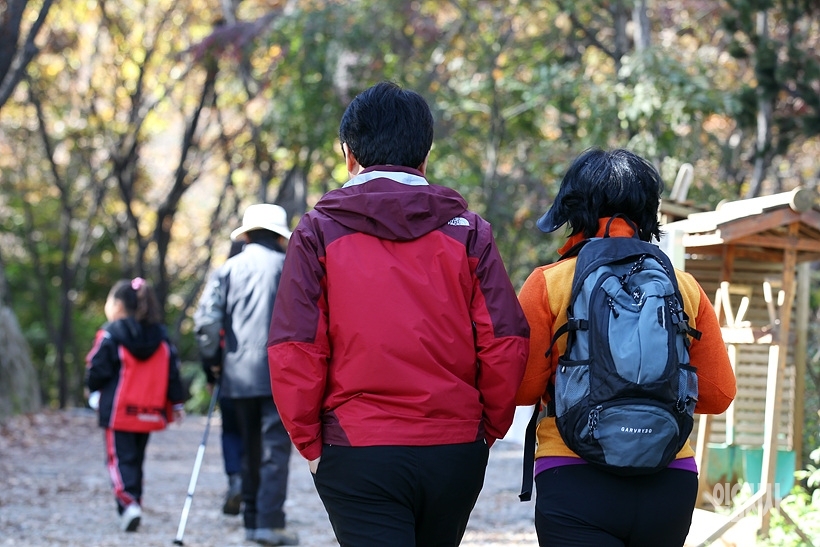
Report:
313,441,489,547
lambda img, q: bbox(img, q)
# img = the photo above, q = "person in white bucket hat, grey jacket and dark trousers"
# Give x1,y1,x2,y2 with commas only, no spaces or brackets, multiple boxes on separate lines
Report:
194,203,299,545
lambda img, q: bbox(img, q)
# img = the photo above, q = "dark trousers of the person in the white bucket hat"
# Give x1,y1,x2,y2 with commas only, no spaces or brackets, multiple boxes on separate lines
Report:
233,395,292,529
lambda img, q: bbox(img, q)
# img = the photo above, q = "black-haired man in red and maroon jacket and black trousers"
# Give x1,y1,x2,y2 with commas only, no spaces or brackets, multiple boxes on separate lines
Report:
268,82,529,547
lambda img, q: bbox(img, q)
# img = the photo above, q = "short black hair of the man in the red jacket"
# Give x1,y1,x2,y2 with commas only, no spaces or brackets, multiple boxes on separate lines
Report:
339,82,433,169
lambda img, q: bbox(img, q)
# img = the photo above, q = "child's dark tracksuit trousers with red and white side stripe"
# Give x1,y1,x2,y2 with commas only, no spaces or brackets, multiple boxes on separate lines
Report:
104,428,149,514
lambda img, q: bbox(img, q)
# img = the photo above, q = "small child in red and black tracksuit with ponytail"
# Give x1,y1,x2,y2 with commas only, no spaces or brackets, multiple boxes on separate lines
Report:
86,277,186,532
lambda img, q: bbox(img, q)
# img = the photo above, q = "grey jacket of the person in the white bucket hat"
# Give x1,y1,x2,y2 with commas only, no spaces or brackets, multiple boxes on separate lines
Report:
194,243,285,399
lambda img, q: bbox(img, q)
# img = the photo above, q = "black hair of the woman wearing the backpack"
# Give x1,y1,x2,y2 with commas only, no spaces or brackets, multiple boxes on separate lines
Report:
553,148,664,241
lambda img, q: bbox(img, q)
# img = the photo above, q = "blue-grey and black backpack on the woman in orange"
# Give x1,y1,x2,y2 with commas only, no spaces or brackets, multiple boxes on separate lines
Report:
521,220,700,500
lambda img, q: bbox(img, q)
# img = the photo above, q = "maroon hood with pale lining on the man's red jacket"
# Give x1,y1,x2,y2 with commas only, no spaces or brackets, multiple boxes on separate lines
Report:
315,165,467,241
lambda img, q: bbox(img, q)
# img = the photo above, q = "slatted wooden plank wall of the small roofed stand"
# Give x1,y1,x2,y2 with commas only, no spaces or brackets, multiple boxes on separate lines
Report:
686,256,797,450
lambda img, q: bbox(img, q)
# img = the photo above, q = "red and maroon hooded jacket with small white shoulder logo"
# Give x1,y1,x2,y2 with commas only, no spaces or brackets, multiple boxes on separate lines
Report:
268,166,529,460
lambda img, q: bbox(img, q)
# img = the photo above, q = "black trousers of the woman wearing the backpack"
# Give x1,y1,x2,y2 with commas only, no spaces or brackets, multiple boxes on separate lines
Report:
535,465,698,547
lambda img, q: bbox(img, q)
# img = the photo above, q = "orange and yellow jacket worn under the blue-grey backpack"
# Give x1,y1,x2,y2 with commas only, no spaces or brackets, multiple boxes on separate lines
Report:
515,218,737,458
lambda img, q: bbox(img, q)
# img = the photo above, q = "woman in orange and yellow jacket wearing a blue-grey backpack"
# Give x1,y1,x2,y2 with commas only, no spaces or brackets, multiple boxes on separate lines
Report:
516,149,736,547
